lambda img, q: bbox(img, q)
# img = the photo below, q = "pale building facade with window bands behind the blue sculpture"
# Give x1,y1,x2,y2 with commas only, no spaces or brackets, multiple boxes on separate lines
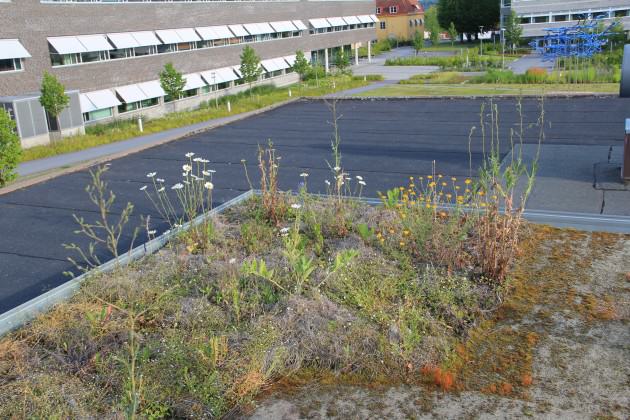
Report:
506,0,630,38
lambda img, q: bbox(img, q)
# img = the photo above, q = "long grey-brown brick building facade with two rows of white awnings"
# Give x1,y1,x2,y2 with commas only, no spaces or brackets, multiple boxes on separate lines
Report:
0,0,378,147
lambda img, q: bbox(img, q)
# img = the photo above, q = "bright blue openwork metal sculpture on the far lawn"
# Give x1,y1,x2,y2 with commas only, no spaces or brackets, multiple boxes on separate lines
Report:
529,20,619,61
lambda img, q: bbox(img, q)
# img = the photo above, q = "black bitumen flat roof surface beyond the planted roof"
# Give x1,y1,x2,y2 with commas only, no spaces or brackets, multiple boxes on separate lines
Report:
0,98,630,313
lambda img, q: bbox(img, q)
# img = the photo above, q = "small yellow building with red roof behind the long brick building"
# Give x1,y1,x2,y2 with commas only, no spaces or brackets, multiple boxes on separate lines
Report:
376,0,424,41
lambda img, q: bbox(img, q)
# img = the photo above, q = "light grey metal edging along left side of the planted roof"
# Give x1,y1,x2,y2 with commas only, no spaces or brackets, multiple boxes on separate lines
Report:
0,191,255,337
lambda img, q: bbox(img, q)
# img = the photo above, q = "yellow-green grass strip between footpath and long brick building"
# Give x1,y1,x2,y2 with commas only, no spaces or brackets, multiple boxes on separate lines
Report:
22,76,369,162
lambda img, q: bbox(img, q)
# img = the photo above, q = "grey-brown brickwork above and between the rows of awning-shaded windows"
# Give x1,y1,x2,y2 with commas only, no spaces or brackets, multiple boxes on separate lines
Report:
0,0,376,96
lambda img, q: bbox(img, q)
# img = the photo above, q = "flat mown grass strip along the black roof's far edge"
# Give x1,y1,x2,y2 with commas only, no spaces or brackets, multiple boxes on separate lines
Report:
355,83,619,97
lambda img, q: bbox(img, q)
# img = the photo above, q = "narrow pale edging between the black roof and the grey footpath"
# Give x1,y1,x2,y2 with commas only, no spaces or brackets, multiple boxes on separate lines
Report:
0,97,302,195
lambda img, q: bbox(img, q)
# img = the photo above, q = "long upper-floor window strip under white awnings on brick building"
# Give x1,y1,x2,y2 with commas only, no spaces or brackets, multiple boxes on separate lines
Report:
50,31,302,67
